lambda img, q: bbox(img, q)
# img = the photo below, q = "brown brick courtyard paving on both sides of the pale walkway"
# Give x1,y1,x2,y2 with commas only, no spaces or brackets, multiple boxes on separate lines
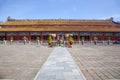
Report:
0,44,120,80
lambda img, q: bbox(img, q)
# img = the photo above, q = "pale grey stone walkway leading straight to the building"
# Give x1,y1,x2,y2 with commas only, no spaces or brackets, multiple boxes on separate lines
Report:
34,47,86,80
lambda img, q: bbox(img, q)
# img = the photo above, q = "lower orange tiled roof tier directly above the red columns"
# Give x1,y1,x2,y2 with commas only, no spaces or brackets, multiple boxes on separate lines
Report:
0,27,120,32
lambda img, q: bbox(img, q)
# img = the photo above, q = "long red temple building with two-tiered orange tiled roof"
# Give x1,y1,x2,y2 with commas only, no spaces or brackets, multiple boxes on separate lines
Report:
0,18,120,42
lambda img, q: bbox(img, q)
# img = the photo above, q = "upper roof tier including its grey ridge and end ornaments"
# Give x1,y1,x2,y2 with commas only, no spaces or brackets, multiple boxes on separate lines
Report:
0,17,120,26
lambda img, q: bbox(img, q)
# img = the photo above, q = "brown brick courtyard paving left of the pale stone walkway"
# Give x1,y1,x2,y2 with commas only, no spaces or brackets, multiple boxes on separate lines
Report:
0,44,53,80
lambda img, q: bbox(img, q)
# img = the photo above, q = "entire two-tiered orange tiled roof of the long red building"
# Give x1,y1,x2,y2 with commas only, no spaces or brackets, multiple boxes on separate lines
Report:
0,19,120,32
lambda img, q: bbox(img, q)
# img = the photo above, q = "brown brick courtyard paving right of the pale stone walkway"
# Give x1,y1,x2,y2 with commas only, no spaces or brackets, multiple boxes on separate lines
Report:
68,45,120,80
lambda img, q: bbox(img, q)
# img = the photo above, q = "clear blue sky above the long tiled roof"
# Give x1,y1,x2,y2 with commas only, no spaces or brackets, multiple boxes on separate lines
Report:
0,0,120,21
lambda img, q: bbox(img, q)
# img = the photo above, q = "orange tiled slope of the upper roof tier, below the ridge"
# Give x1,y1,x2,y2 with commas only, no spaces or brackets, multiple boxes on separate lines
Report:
2,19,117,26
